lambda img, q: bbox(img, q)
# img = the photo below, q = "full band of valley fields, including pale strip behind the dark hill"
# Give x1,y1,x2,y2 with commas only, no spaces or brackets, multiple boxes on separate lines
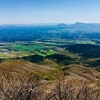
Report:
0,39,95,62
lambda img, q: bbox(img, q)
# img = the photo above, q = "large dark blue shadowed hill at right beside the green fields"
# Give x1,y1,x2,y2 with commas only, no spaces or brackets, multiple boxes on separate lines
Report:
66,44,100,58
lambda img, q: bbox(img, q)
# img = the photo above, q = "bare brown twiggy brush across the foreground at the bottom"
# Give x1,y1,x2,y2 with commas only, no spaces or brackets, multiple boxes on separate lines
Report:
0,72,100,100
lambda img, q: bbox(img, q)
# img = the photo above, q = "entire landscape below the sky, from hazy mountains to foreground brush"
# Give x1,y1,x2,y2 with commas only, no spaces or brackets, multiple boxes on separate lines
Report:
0,23,100,100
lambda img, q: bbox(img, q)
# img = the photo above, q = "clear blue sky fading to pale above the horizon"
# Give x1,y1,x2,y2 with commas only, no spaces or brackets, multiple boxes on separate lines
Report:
0,0,100,24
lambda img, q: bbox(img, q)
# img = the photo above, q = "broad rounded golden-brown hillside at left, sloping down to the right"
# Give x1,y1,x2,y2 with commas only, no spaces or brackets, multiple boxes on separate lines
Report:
0,60,56,79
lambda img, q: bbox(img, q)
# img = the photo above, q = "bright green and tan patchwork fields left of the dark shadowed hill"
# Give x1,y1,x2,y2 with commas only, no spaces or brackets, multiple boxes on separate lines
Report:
0,42,58,58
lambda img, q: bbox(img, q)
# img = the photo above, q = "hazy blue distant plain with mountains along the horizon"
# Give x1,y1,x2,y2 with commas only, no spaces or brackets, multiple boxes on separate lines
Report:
0,22,100,42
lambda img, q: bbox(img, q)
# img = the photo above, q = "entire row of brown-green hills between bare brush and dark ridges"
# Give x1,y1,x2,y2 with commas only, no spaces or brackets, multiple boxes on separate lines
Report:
0,59,100,81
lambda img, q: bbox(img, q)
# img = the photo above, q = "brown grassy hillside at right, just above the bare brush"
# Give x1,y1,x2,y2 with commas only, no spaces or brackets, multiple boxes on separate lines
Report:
62,64,100,82
